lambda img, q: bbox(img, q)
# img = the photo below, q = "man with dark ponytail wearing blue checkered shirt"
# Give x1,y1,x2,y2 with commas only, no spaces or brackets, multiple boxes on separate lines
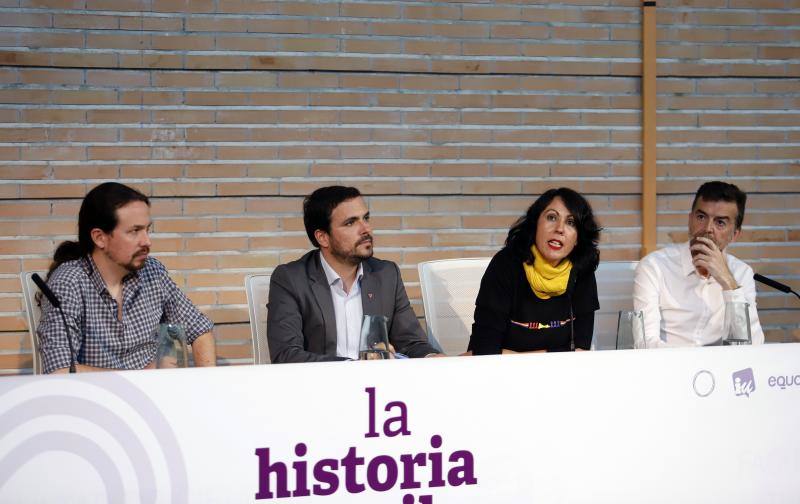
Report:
37,182,216,373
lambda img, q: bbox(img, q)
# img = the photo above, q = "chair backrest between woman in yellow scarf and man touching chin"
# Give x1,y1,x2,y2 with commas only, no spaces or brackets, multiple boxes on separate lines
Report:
592,261,639,350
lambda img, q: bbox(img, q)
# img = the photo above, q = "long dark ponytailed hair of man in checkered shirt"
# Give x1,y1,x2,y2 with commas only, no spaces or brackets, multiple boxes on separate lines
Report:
47,182,150,278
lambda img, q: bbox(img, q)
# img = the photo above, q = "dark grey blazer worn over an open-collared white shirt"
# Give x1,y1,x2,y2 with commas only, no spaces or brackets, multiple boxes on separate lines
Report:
267,250,437,364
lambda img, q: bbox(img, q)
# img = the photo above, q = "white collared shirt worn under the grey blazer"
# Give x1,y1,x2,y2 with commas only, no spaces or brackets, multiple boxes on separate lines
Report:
319,254,364,360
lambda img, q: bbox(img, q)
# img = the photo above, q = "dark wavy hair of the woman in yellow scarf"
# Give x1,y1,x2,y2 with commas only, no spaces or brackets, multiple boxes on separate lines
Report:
506,187,602,272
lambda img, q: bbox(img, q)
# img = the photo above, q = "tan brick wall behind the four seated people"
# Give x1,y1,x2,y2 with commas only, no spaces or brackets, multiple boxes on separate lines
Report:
0,0,800,374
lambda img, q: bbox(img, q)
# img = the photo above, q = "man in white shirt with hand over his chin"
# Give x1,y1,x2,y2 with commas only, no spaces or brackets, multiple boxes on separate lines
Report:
633,181,764,348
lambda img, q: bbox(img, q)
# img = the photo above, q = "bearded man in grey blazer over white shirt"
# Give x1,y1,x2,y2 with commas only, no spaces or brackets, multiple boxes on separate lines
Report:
267,186,441,363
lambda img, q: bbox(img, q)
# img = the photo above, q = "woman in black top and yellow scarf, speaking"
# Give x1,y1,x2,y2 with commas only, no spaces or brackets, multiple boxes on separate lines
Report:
469,187,601,355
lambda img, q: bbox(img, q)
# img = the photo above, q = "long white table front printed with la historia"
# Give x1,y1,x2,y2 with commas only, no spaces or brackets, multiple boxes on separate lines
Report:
0,343,800,504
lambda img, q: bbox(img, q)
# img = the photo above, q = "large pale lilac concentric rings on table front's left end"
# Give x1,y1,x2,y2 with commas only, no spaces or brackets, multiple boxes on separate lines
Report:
0,373,189,504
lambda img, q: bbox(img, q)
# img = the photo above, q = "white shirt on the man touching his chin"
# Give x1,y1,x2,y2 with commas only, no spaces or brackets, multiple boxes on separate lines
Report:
633,242,764,348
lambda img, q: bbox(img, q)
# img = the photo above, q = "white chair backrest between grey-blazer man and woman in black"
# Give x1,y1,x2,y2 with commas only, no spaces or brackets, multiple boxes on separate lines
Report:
417,257,491,355
